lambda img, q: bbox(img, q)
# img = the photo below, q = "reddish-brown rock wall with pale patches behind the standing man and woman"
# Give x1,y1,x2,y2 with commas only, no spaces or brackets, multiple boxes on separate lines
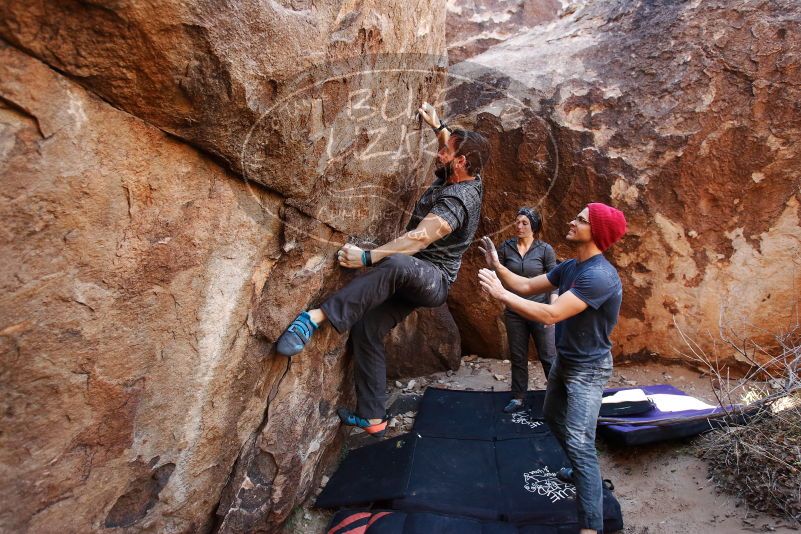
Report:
450,1,801,360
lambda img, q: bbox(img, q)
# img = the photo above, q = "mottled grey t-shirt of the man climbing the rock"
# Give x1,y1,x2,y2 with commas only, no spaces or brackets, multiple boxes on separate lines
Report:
406,171,484,284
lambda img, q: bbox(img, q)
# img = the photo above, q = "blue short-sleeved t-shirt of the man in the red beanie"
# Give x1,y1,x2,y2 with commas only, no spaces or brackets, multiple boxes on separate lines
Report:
547,254,623,363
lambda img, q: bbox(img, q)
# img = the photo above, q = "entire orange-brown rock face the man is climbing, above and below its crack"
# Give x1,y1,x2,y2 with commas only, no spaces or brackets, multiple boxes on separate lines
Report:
0,1,450,532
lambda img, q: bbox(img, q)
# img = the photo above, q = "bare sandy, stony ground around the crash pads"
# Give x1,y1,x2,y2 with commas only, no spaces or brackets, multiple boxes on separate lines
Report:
282,356,799,534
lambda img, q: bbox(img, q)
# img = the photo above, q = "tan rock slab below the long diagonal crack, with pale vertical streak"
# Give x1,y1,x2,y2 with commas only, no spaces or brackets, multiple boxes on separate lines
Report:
0,46,286,532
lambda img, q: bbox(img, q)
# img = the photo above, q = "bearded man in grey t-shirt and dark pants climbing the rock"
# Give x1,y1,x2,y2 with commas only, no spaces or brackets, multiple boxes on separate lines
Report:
277,103,489,437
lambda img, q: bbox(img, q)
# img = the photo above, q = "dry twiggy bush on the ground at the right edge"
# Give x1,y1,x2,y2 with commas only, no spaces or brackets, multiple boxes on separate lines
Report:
676,314,801,524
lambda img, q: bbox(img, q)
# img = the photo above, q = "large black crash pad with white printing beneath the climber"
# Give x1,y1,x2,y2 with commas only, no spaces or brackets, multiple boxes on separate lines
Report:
316,389,623,534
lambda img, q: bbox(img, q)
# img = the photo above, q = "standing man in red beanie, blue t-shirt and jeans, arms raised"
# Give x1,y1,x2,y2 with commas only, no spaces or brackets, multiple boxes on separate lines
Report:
478,203,626,534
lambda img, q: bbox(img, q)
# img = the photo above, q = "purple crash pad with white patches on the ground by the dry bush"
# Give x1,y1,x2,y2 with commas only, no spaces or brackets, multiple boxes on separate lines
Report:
598,384,732,445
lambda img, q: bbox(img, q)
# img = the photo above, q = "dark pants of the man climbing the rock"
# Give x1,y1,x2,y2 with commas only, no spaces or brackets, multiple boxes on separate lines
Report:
320,254,448,419
